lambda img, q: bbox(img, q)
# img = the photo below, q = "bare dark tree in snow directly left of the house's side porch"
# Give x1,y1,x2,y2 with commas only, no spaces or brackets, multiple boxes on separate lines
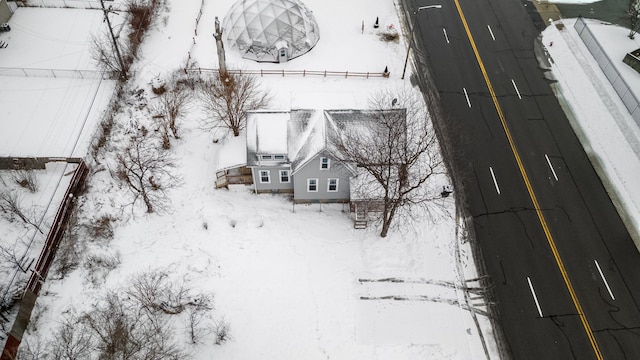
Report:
116,135,179,213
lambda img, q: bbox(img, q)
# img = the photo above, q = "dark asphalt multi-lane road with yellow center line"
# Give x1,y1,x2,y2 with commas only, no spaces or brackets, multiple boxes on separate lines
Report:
404,0,640,359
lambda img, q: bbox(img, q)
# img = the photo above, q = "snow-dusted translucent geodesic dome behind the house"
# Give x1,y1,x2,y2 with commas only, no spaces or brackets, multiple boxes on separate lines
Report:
223,0,320,62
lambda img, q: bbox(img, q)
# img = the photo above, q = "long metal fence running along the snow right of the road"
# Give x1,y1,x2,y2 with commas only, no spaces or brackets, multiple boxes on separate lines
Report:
573,16,640,126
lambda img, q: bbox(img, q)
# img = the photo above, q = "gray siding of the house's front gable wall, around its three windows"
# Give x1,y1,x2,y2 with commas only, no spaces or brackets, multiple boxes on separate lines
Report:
293,153,351,203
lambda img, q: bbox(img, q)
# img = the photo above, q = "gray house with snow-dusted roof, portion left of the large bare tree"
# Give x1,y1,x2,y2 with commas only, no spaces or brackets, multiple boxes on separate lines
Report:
246,110,368,203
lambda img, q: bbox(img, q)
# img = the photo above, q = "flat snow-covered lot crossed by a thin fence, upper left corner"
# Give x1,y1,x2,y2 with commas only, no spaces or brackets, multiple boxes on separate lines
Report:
0,7,115,157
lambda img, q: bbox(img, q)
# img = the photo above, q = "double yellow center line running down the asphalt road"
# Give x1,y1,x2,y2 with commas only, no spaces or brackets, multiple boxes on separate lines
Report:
454,0,603,360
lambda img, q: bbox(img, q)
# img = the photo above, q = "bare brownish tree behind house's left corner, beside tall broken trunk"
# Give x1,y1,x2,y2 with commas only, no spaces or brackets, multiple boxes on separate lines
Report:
199,73,271,136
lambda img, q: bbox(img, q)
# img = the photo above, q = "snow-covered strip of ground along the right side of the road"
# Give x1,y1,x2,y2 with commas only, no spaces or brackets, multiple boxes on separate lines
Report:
542,19,640,246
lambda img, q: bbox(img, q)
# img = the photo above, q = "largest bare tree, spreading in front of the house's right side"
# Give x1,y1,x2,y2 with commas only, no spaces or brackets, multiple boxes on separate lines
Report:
335,91,445,237
